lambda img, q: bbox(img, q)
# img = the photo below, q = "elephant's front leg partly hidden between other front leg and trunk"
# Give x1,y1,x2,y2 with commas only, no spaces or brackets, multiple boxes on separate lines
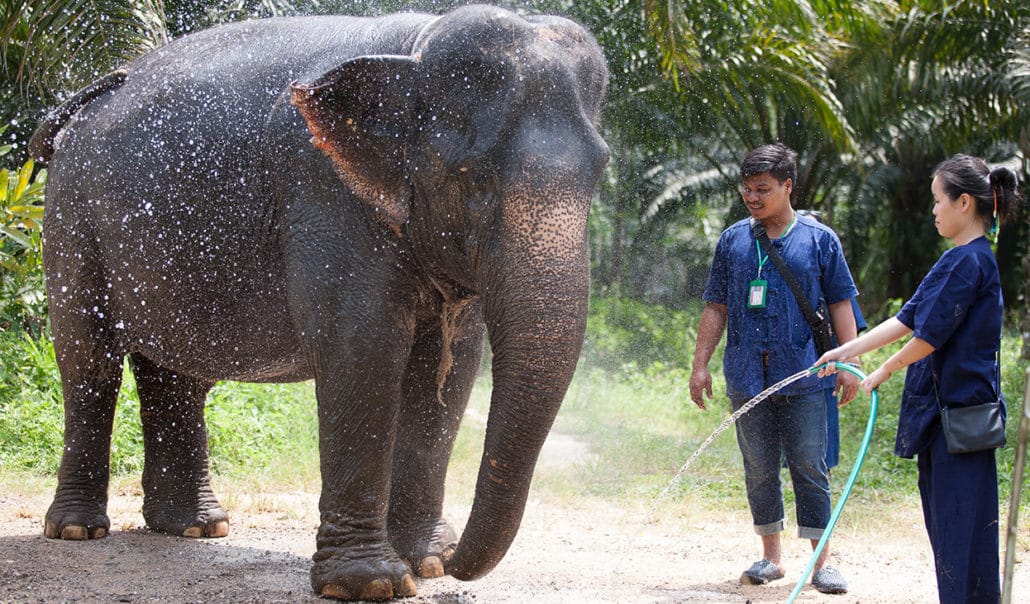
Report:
388,307,483,577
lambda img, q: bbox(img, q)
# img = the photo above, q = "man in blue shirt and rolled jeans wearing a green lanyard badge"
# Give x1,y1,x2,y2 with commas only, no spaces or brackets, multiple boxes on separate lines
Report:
690,143,858,594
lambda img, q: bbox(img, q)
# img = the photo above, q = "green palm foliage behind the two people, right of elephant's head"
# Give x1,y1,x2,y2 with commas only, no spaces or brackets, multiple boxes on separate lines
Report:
580,0,1030,314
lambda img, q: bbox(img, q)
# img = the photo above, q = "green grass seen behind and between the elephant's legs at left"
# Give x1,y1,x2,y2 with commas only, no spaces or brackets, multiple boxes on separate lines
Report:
0,330,318,480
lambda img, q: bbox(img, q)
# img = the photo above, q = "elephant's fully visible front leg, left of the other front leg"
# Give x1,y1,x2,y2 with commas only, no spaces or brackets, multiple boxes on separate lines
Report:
311,321,415,600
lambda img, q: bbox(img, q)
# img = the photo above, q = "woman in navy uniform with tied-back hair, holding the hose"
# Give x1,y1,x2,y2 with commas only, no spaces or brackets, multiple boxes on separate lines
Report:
817,155,1020,604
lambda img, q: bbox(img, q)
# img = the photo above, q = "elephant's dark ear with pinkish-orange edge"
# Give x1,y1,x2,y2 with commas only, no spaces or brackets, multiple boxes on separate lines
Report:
290,56,417,226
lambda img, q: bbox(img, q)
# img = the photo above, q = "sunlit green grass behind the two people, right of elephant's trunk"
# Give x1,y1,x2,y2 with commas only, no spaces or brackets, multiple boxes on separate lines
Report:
548,332,1030,523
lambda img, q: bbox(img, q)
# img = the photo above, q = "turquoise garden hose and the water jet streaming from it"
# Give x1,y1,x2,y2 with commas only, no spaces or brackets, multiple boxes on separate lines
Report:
648,362,880,604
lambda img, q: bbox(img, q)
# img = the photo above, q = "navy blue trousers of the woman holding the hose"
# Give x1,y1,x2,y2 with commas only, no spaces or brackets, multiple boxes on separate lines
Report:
918,425,1001,604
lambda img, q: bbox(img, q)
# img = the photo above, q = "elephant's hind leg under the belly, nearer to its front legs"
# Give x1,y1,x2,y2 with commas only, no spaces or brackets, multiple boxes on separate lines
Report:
131,355,229,537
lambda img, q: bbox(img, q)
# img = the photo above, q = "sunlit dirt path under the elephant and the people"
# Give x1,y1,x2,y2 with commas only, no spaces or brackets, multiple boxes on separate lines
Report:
0,422,1030,604
